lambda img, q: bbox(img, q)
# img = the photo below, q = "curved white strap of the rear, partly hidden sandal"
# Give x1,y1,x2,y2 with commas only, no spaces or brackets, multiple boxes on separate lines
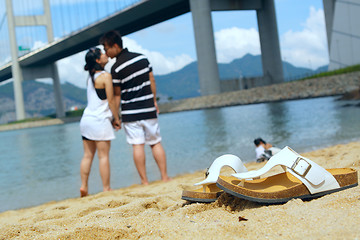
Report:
194,154,247,186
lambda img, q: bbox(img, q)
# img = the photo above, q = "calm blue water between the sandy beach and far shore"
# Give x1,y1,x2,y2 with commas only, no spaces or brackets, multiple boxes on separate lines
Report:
0,97,360,212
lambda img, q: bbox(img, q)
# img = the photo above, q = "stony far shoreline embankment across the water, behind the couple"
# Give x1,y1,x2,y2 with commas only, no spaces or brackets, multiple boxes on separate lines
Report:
0,72,360,132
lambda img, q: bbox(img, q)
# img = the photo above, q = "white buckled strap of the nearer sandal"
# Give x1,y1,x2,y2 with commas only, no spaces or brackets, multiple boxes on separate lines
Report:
232,147,340,194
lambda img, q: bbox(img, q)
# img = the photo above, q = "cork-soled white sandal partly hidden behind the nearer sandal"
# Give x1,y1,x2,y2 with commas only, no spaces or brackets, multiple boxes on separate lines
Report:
181,154,247,203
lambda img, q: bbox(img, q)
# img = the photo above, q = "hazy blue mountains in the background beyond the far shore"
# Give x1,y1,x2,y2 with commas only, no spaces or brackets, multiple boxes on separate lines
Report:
0,54,327,123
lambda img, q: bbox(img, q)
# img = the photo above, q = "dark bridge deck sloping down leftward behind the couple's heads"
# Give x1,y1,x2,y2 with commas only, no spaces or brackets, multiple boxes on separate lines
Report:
0,0,190,82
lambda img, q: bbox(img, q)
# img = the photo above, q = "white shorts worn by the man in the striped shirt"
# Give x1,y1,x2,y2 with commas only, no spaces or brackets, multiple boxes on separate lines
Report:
123,118,161,145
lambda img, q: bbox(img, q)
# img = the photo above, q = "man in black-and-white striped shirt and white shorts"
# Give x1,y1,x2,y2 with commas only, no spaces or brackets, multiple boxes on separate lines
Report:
100,31,170,185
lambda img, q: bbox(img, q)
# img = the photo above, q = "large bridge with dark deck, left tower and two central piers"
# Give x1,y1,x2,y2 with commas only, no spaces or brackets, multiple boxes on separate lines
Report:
0,0,283,119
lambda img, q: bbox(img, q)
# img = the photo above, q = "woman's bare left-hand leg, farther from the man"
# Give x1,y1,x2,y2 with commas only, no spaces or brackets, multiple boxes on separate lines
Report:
80,140,96,197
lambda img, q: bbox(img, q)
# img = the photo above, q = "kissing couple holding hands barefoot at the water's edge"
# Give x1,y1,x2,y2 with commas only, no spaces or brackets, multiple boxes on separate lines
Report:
80,31,170,197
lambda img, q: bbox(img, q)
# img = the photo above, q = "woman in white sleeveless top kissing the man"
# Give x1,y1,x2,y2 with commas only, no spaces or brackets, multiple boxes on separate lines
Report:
80,48,121,197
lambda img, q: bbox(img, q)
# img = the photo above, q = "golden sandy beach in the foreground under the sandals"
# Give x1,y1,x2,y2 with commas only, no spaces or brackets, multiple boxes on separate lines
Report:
0,142,360,240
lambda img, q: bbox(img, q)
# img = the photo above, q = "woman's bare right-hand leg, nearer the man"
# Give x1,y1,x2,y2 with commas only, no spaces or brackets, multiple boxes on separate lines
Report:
96,141,111,192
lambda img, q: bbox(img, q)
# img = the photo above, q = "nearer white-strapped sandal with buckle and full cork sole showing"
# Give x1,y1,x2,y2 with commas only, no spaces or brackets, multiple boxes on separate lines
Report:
217,147,358,203
